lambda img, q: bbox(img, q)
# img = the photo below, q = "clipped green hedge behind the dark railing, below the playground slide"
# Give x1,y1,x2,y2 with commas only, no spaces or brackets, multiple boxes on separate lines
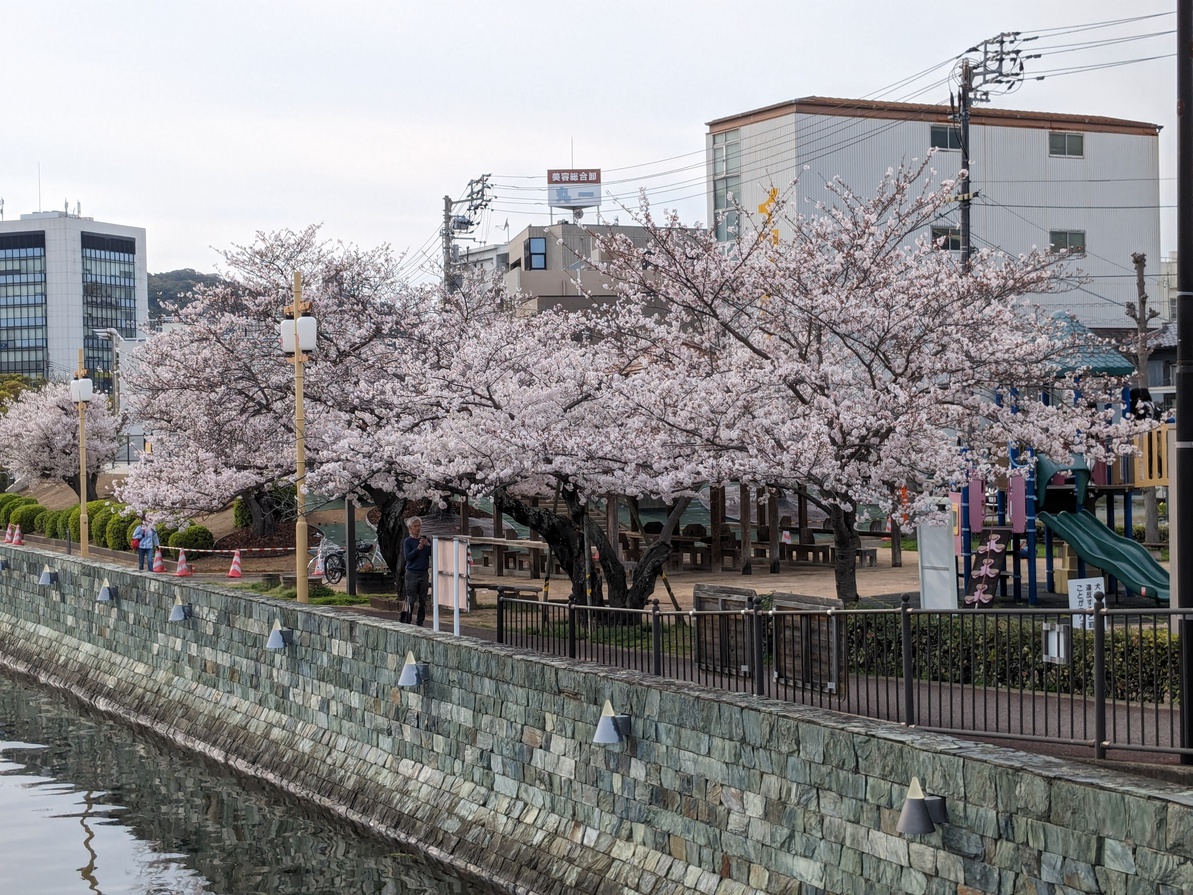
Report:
846,610,1180,704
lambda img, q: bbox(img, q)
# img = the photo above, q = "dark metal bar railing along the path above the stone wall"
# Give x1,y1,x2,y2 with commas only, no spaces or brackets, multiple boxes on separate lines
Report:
497,595,1193,758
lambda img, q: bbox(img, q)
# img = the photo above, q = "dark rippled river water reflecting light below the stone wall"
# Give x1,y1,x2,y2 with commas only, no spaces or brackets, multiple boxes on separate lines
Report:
0,671,500,895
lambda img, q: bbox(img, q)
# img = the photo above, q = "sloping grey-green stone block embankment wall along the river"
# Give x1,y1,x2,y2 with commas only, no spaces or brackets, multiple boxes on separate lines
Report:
0,548,1193,895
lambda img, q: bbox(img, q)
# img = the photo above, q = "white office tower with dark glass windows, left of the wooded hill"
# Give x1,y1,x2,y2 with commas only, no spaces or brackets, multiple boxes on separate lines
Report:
0,211,149,391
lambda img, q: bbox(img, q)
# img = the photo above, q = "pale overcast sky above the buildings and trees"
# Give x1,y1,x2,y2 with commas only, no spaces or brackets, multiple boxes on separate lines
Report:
0,0,1176,280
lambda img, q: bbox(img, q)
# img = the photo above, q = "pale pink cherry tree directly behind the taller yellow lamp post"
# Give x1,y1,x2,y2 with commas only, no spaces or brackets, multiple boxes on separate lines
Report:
119,227,428,562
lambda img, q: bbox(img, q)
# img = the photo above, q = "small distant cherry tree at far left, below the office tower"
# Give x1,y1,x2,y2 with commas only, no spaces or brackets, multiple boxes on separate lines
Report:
0,382,120,500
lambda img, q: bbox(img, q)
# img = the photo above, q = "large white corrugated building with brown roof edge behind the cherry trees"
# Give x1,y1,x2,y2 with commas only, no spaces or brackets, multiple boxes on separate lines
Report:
706,97,1160,328
